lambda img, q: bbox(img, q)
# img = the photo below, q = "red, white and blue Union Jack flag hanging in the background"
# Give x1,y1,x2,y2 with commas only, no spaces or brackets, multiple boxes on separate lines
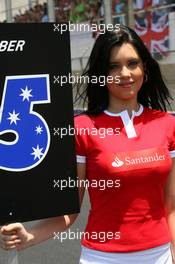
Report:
134,0,169,56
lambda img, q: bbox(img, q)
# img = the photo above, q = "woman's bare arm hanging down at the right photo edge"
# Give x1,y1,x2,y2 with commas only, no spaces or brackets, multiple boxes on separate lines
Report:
165,158,175,263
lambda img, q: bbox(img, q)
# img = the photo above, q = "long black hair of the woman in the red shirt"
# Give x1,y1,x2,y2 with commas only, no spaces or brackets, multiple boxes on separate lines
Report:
74,25,172,114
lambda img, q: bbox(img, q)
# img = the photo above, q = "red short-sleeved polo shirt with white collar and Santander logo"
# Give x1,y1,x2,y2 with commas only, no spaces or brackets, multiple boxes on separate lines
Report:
75,106,175,252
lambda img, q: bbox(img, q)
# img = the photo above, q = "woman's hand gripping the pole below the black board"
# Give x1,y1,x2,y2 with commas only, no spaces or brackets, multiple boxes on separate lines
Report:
0,223,33,250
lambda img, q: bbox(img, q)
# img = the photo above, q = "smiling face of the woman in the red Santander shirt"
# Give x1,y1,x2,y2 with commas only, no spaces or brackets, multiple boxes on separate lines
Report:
107,43,144,100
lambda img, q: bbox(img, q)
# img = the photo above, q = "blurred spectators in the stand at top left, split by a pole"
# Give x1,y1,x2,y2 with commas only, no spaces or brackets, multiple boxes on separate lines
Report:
1,0,103,23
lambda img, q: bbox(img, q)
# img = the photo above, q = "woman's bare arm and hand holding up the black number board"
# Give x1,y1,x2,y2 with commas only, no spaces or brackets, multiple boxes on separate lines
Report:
0,163,86,250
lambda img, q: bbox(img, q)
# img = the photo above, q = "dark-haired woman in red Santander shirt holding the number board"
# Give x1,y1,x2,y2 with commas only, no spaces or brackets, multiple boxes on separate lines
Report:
1,26,175,264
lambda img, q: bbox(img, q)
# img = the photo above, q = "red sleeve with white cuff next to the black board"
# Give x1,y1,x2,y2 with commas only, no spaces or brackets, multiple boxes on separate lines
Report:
74,115,88,163
